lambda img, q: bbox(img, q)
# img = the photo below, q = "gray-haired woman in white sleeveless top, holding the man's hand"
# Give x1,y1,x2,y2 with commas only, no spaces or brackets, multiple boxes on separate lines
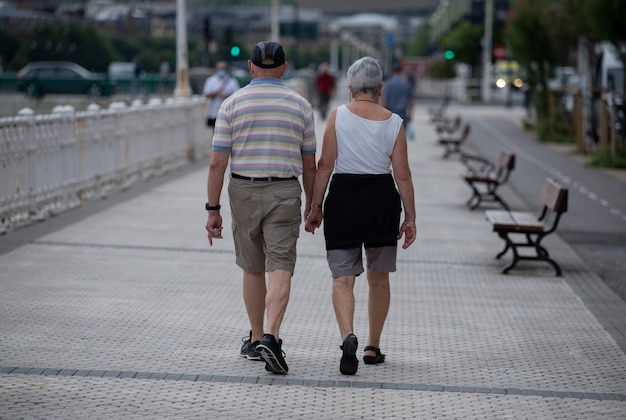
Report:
305,57,416,375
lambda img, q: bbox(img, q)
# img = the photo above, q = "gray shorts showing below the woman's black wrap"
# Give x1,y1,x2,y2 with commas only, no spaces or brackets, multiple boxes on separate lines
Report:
326,246,398,278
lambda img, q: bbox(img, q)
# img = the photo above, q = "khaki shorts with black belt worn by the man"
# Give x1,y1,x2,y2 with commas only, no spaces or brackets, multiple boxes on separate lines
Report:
228,178,302,273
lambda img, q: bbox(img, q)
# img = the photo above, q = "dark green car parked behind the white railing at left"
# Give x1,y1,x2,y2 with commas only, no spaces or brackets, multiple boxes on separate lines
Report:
16,61,112,97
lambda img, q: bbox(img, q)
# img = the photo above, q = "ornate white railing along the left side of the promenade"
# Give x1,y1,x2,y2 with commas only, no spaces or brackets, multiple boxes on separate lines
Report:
0,98,211,233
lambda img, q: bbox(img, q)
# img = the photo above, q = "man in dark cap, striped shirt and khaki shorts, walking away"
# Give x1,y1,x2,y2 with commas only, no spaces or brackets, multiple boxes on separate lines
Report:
206,41,316,374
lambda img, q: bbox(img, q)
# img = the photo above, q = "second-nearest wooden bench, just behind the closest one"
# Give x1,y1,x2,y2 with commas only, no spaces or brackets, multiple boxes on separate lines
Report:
461,152,515,210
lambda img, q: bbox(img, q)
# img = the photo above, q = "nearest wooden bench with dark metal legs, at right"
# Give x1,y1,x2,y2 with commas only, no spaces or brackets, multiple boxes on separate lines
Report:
485,179,567,276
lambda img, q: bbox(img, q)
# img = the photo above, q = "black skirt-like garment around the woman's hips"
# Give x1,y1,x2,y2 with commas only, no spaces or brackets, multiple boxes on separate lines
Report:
324,174,402,250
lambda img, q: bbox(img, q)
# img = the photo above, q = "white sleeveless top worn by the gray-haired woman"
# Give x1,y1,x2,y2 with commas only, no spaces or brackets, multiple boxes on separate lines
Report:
335,105,402,175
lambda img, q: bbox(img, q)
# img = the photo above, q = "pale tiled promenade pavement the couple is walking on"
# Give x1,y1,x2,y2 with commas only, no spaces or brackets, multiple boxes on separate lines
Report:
0,102,626,419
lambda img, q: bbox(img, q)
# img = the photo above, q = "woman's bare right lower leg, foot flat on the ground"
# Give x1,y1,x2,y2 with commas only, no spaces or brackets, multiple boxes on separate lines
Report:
365,268,391,356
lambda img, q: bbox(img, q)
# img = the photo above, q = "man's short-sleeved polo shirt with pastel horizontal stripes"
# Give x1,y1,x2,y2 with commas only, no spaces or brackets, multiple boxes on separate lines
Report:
213,78,316,178
